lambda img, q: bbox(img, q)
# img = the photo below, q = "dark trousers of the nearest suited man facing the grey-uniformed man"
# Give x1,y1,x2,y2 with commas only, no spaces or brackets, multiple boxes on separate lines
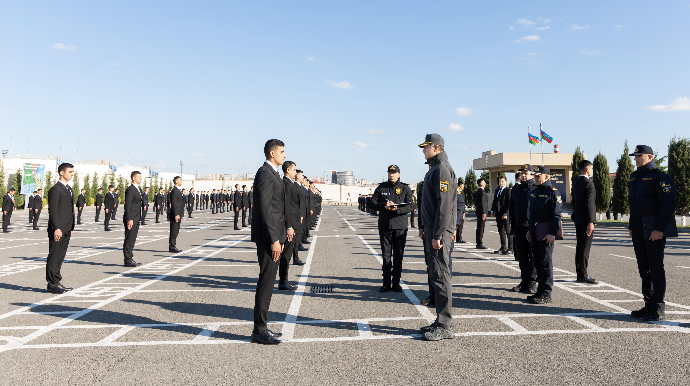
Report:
252,243,279,334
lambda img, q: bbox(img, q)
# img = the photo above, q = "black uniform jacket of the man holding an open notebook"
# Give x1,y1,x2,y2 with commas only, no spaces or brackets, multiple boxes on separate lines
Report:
371,180,414,231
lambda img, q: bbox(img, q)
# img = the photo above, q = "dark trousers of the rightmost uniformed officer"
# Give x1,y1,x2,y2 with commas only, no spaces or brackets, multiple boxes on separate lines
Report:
632,229,673,311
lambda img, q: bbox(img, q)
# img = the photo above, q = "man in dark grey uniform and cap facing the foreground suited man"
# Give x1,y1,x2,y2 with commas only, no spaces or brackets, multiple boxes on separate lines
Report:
419,134,457,341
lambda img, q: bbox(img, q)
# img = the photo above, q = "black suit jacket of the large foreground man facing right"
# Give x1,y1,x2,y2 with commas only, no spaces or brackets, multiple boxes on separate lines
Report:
251,163,287,245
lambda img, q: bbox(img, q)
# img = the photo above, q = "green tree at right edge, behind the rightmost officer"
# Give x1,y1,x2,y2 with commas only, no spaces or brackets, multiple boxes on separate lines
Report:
668,137,690,216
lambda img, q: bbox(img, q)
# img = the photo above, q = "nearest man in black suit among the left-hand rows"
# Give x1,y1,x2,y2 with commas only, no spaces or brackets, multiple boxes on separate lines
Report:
46,163,74,294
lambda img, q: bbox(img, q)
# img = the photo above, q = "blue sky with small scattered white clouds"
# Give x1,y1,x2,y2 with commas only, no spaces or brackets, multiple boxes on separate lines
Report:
0,0,690,181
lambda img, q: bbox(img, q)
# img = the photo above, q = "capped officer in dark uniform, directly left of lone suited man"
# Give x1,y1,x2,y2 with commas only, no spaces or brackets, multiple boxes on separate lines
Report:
527,166,562,304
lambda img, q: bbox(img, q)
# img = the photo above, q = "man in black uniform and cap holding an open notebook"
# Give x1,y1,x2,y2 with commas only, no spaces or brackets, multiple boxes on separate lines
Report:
371,165,414,292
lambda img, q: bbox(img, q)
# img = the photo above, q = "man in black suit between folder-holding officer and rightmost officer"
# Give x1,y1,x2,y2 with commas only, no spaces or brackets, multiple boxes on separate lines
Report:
572,160,599,284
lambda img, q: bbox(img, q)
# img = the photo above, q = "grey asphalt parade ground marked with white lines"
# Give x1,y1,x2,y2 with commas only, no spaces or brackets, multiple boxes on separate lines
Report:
0,205,690,385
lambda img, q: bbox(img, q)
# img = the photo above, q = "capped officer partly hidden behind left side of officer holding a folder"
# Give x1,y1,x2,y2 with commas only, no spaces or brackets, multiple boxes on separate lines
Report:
508,164,537,294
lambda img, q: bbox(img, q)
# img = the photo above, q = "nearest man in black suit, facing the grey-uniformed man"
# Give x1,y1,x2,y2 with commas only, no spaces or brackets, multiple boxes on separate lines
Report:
250,139,288,344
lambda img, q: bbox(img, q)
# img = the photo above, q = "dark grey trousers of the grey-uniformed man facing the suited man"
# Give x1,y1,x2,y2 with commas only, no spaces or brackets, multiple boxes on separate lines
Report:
424,226,453,328
